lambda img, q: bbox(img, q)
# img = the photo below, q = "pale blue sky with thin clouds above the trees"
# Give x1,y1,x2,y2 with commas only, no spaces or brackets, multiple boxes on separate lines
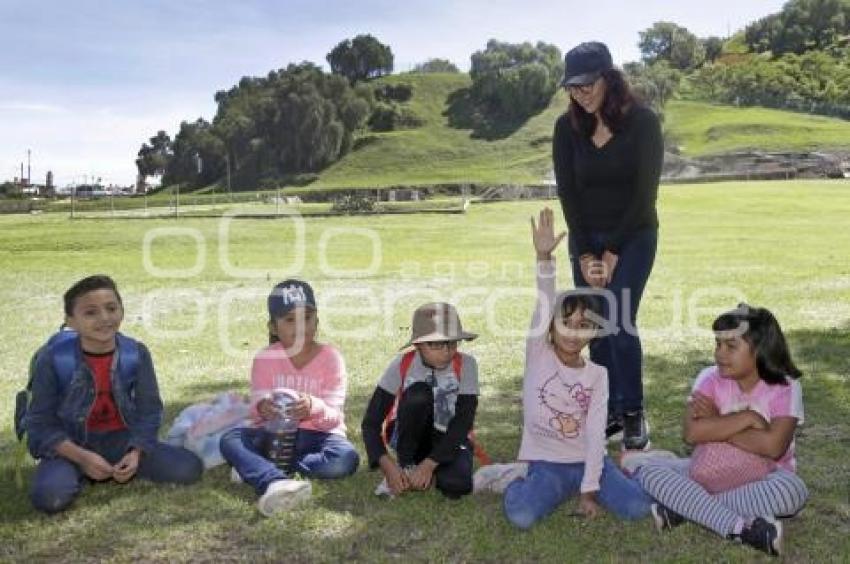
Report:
0,0,784,186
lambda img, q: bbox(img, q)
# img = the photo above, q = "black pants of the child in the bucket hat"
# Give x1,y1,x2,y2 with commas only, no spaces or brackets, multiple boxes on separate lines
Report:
395,382,472,498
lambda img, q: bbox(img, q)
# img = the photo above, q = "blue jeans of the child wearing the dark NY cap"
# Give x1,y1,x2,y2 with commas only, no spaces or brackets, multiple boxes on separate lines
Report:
219,427,360,495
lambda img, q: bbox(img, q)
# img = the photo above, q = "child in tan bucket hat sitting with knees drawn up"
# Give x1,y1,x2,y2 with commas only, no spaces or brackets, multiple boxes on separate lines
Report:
362,303,478,498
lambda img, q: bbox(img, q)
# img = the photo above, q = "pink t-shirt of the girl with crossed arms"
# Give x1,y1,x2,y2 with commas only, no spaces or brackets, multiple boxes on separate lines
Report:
693,366,803,472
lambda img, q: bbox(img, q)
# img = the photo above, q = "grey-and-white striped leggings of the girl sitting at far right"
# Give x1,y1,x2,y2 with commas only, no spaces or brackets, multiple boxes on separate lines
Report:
637,458,809,537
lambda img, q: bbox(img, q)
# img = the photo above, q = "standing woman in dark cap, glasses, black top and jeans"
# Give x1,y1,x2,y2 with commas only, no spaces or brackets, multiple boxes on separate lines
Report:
552,42,664,449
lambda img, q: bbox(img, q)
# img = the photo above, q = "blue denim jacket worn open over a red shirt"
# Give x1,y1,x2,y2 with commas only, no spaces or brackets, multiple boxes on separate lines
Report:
26,337,162,458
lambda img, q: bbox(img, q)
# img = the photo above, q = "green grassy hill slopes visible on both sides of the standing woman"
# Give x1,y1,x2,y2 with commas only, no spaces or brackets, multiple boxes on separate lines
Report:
298,74,850,188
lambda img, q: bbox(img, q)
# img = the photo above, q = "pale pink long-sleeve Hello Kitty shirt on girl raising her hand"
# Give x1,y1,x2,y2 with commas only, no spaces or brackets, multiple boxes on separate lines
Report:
517,261,608,492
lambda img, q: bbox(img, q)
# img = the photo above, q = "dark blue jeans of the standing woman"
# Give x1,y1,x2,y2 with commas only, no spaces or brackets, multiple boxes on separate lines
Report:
569,228,658,415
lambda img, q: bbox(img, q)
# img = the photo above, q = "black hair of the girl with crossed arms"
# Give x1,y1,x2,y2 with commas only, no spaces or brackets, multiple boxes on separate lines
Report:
711,303,803,384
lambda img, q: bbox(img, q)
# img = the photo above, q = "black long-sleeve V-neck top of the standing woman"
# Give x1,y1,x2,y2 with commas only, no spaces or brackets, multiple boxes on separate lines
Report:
552,106,664,256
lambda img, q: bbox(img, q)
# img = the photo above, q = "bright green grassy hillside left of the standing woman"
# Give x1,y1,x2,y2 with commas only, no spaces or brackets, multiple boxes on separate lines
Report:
314,74,566,187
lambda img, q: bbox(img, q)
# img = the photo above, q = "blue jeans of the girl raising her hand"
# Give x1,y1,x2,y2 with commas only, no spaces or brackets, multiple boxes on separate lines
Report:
502,456,652,529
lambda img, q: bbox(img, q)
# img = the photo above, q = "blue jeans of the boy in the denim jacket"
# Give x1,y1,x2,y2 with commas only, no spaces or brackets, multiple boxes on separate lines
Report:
30,431,204,513
